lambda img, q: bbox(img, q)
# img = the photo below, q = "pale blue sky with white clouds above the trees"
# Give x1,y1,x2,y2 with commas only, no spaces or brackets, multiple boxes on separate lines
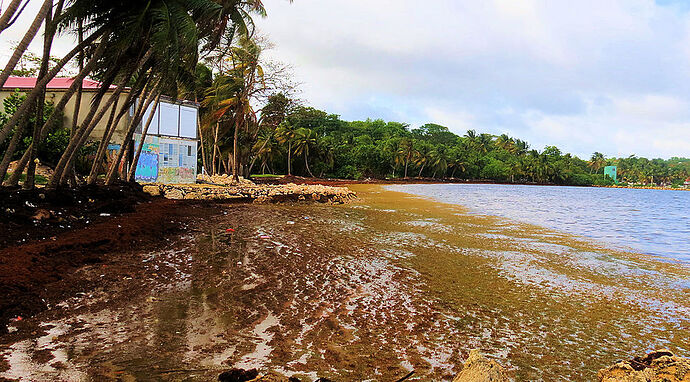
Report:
0,0,690,158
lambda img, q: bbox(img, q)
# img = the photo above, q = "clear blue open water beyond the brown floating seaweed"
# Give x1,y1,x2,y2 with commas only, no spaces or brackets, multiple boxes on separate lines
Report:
387,184,690,262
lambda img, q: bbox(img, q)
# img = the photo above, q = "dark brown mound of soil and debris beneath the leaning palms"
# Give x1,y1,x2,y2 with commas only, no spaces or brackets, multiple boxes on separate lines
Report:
0,184,218,333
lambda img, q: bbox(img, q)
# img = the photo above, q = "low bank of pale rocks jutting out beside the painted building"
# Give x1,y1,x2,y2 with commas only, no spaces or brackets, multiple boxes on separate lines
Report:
144,181,357,204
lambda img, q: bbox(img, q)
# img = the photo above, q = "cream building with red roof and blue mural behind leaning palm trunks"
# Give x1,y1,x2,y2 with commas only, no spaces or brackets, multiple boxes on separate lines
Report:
0,77,199,183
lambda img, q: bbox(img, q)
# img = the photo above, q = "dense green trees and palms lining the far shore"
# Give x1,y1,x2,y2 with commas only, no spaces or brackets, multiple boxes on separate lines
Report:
245,105,690,185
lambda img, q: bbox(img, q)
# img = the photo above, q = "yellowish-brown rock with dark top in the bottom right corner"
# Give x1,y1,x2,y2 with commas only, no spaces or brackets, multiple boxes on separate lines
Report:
597,350,690,382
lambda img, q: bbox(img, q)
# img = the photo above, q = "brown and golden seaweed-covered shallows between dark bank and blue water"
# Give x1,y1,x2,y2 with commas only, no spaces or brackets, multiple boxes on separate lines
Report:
0,185,690,381
